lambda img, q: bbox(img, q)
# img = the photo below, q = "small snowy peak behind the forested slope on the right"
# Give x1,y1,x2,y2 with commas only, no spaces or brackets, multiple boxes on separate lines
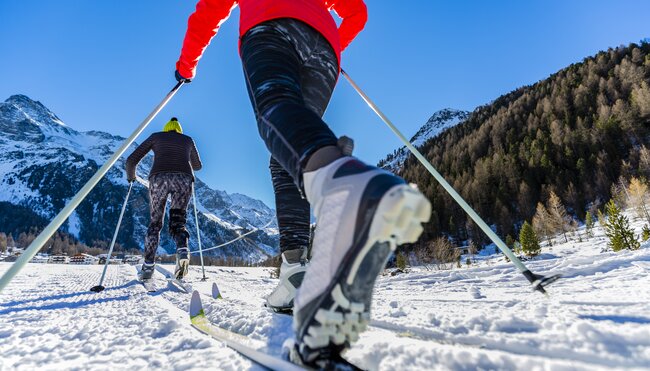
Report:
378,108,469,172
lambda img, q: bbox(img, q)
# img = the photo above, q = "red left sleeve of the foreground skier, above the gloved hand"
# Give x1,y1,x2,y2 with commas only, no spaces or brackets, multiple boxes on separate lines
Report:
176,0,238,79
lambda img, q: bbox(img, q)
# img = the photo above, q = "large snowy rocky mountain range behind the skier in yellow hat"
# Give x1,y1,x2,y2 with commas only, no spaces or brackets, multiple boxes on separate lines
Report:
0,95,278,261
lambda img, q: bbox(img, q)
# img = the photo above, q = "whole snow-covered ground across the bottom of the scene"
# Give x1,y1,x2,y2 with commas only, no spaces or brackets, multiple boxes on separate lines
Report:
0,219,650,370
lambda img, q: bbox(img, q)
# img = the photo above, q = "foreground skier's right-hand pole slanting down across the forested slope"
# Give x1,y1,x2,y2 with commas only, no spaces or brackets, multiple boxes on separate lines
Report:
341,69,560,294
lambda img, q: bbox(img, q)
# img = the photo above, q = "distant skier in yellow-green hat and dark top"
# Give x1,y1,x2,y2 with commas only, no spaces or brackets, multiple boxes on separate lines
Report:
126,117,203,280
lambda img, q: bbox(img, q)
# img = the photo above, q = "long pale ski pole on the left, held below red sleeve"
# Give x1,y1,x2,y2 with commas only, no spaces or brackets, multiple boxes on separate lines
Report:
0,81,183,292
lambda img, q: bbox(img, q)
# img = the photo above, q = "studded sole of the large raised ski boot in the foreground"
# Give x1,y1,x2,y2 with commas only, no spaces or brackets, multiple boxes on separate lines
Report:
294,184,431,364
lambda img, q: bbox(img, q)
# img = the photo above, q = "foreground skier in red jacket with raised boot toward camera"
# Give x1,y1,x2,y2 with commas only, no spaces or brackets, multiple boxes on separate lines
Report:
176,0,431,366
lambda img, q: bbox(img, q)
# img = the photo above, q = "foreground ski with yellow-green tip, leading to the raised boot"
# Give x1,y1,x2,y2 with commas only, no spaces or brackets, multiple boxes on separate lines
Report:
190,291,312,371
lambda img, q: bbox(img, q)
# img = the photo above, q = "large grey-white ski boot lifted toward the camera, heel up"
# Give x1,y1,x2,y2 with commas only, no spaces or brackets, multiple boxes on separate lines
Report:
293,156,431,366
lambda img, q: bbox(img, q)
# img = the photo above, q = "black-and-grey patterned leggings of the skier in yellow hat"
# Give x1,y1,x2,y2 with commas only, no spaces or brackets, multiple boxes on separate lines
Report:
144,173,194,264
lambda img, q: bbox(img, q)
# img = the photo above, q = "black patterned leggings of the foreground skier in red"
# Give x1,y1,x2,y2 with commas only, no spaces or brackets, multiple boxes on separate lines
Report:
241,19,339,252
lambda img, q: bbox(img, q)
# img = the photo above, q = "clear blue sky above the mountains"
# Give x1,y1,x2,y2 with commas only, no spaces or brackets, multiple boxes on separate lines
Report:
0,0,650,205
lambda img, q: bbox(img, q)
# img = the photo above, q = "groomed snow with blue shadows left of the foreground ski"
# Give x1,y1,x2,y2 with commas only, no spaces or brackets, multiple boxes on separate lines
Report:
0,263,252,370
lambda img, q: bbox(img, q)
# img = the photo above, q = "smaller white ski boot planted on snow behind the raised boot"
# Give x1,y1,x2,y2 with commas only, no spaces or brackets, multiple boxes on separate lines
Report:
266,249,309,314
